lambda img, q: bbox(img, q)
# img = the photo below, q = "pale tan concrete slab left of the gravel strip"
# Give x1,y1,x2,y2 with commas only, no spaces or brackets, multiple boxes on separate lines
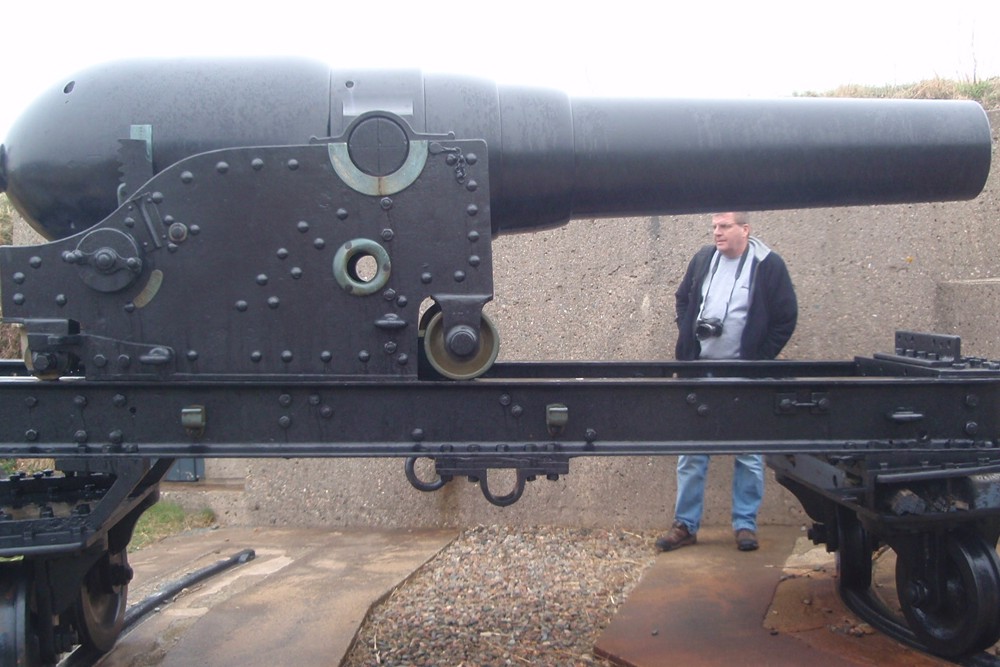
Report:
100,528,456,667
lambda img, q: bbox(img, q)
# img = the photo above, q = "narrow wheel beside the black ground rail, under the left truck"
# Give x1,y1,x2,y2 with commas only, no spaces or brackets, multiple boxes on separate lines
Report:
75,549,132,653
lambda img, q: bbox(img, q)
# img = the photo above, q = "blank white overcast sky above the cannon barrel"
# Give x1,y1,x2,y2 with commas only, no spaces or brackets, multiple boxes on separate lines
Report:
0,0,1000,141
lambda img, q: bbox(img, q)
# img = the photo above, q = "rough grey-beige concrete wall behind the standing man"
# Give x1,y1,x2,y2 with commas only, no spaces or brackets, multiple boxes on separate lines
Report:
9,112,1000,529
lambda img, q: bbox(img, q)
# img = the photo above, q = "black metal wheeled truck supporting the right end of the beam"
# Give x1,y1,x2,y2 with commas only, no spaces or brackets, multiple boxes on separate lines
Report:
769,446,1000,659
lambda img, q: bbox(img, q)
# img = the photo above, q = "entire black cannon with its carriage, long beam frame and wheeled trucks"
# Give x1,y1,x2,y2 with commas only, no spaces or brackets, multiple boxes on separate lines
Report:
0,61,1000,665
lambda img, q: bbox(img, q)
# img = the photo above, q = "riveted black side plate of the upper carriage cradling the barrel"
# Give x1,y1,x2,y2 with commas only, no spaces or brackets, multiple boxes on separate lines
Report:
0,141,493,380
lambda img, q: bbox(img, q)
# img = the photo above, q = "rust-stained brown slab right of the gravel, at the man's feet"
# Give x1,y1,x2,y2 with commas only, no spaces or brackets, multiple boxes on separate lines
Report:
594,526,951,667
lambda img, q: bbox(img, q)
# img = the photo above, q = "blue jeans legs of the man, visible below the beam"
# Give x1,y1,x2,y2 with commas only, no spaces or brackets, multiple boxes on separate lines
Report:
674,454,764,534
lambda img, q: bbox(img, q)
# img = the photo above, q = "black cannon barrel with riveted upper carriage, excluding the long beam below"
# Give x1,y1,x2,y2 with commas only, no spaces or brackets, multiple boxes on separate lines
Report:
0,61,990,378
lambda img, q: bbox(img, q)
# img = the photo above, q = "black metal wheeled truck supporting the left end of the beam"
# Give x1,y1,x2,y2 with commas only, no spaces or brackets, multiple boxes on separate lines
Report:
0,457,171,667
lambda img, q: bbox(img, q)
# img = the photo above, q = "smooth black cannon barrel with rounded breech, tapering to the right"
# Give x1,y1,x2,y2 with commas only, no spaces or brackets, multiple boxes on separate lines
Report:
0,59,990,238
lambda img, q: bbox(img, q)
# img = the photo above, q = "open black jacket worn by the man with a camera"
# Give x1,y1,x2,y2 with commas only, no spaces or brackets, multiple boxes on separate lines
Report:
675,245,799,361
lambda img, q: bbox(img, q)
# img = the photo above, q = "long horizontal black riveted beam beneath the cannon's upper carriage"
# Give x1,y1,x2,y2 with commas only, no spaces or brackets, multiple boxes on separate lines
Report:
0,376,1000,458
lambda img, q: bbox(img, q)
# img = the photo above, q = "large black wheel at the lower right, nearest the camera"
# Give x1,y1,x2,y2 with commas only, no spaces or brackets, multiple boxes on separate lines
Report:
896,533,1000,657
